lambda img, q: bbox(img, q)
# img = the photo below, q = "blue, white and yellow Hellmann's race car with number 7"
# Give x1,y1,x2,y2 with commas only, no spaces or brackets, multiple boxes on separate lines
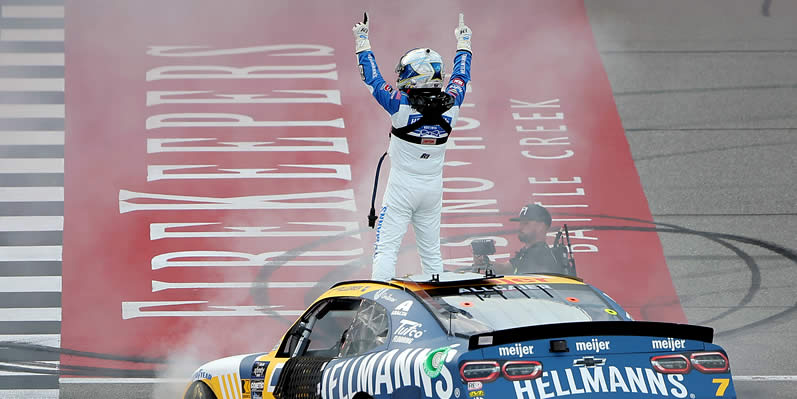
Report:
184,270,736,399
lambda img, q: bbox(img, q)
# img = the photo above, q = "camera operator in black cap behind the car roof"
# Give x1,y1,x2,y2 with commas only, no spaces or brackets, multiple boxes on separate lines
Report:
473,204,568,274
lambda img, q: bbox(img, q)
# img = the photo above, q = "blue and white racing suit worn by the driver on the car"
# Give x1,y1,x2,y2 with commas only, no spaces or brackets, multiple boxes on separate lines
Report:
357,50,472,281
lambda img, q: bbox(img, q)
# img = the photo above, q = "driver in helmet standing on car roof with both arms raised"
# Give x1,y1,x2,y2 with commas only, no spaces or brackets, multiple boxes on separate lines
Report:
352,14,472,281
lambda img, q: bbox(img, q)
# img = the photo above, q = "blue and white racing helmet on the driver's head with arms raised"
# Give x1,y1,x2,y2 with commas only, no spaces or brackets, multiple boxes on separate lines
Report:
396,48,445,90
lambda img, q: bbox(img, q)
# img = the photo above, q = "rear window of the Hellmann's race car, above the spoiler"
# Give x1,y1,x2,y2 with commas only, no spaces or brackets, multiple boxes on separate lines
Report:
425,284,622,335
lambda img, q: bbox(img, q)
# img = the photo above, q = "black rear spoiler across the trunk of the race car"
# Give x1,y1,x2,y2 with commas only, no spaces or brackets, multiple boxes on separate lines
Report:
468,321,714,350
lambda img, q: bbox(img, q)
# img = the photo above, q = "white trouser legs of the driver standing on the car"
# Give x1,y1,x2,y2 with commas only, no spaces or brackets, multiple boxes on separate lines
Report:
371,169,443,281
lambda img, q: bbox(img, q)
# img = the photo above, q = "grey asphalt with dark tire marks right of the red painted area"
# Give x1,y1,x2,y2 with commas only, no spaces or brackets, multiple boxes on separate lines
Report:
3,0,797,399
